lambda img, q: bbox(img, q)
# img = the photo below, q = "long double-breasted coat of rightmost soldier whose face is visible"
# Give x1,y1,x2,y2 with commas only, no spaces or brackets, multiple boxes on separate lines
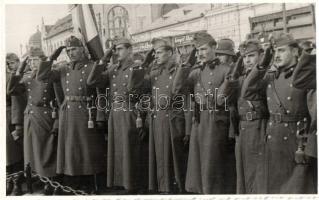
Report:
244,62,316,193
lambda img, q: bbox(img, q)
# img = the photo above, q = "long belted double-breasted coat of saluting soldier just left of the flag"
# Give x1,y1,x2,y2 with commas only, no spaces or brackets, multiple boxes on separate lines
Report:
37,60,106,176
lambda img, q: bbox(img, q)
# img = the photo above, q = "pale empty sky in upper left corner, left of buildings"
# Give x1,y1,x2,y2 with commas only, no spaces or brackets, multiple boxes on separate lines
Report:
5,4,69,56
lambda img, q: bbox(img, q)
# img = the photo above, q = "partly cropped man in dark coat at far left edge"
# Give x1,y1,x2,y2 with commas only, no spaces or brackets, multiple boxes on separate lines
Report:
6,53,26,195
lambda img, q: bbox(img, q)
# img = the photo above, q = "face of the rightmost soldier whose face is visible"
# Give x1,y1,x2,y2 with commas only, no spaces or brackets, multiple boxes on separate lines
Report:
274,45,298,68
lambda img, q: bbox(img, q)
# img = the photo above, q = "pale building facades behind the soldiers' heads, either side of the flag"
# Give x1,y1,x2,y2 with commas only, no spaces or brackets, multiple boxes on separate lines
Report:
41,3,315,60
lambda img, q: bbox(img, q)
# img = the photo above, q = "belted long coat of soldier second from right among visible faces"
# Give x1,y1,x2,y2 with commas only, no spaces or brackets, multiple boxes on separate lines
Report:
218,70,268,194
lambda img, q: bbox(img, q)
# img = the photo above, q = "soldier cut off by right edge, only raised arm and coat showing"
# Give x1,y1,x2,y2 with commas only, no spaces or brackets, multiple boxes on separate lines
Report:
285,48,318,194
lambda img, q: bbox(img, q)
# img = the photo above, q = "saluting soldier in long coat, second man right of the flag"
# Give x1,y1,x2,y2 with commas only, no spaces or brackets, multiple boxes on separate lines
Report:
130,38,187,194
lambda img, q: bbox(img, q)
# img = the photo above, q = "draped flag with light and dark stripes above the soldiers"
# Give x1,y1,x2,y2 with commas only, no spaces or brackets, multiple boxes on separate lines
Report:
71,4,103,61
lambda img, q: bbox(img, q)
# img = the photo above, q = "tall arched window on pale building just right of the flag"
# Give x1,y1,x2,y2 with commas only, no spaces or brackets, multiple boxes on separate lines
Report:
108,6,128,39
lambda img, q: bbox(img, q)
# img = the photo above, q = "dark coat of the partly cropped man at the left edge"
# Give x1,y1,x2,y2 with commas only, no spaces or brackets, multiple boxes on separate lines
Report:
6,72,26,166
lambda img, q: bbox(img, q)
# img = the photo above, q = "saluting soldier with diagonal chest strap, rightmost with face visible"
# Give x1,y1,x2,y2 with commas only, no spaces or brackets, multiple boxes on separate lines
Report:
243,33,316,193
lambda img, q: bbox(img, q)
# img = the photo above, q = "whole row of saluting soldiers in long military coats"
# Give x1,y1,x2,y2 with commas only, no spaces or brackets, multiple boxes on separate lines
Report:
7,32,317,194
